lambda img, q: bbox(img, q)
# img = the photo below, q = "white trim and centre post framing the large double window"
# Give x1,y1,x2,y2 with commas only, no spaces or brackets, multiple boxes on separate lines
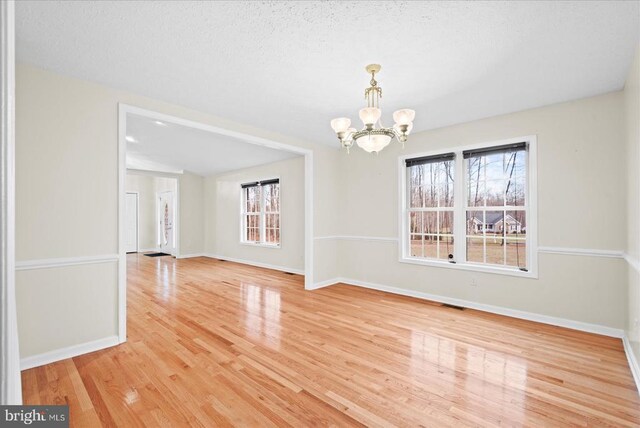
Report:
398,135,538,279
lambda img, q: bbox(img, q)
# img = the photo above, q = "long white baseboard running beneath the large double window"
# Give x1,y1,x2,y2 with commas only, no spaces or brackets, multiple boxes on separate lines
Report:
312,278,624,338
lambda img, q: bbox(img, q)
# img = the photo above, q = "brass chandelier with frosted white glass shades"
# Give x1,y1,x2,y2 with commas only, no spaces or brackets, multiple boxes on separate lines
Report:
331,64,416,154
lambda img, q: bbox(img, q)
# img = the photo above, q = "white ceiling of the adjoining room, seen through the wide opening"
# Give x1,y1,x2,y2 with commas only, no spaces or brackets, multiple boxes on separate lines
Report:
126,114,299,177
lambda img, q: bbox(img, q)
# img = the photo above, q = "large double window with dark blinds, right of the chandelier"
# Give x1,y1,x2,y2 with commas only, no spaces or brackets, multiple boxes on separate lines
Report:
400,137,535,276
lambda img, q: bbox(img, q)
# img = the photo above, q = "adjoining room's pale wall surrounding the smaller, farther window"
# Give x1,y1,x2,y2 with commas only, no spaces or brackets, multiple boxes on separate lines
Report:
205,157,304,272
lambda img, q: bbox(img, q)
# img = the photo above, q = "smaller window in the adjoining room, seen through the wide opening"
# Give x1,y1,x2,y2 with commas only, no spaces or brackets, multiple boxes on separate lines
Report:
241,179,280,247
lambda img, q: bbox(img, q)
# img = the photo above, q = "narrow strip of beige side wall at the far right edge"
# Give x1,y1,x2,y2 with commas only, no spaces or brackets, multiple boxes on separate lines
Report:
624,47,640,361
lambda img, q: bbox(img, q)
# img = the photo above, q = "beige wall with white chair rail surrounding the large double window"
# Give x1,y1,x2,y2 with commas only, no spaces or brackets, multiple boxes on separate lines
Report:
337,92,626,329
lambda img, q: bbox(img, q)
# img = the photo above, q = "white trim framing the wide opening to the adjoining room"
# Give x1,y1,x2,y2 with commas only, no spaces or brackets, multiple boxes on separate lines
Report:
118,103,314,343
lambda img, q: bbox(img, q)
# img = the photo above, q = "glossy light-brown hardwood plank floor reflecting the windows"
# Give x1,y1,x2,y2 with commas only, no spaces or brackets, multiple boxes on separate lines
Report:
22,255,640,427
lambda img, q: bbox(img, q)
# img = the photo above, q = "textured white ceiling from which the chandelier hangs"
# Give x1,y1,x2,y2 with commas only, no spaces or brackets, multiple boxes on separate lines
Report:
16,1,640,147
